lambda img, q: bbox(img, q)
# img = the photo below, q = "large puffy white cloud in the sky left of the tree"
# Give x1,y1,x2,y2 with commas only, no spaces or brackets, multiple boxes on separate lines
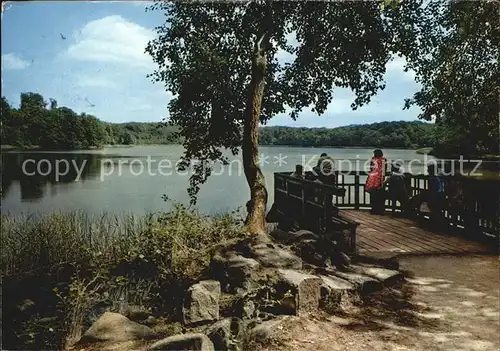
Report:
66,15,154,68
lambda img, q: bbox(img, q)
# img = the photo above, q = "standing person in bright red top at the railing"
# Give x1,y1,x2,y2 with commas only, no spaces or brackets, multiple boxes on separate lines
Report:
365,149,387,215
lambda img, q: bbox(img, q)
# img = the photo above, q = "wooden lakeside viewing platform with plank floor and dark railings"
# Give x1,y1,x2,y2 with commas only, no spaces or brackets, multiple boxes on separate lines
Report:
274,172,500,254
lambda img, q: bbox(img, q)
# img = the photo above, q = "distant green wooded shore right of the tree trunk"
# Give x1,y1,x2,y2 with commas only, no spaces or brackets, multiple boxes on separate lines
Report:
259,121,436,148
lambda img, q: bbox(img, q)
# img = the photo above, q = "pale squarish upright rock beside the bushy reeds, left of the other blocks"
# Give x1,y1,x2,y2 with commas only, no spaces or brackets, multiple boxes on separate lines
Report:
183,280,221,324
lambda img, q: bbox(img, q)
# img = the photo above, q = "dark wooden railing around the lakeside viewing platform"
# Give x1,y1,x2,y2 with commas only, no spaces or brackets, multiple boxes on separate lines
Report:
274,171,500,242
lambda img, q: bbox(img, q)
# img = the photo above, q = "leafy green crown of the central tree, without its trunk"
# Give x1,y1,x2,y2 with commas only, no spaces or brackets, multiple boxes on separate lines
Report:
146,1,428,201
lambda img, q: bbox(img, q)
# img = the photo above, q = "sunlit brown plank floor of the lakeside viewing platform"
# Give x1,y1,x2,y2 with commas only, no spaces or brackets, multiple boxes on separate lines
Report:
341,210,489,254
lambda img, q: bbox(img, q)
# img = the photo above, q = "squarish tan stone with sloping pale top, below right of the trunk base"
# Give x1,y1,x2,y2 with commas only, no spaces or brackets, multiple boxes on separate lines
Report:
278,269,323,315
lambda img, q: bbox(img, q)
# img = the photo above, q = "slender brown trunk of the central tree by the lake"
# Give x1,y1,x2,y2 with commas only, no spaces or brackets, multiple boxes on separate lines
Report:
242,35,267,235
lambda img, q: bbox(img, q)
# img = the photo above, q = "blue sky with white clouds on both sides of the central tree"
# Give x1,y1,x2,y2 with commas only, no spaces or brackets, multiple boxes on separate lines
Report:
1,1,419,127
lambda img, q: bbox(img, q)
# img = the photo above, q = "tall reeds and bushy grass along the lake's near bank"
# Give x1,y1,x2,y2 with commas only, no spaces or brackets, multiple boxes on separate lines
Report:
0,205,243,350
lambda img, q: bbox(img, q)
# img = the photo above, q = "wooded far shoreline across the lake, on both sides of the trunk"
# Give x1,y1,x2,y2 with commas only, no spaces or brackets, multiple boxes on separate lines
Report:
1,93,436,150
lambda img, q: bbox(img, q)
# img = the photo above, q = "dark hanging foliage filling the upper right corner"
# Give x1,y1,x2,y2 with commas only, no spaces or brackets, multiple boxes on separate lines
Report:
406,0,500,156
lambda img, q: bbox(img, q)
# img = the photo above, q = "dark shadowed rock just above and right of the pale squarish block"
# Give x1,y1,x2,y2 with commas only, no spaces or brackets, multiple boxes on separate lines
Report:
211,252,260,292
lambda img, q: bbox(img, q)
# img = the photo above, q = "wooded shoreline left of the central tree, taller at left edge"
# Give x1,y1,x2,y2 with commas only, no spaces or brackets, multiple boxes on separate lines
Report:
1,93,178,150
